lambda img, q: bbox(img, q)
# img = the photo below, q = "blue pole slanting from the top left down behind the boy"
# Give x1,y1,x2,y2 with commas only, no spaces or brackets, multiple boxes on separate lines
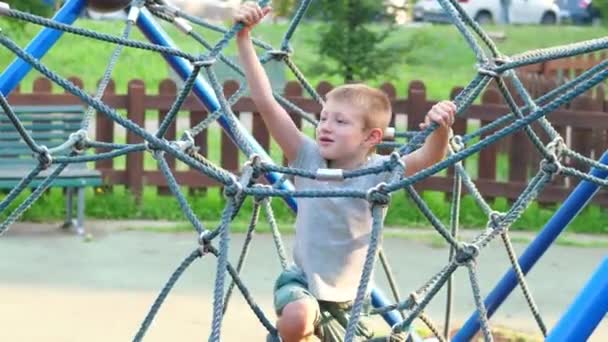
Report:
137,9,401,326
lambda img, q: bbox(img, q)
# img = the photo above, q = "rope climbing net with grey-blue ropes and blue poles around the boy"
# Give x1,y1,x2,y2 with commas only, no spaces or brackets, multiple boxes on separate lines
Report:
0,0,608,341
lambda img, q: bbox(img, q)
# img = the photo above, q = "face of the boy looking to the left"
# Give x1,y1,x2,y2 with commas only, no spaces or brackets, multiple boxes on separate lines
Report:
316,99,381,168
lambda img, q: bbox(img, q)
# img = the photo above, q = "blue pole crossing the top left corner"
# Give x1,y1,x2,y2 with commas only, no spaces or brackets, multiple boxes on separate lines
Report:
0,0,86,96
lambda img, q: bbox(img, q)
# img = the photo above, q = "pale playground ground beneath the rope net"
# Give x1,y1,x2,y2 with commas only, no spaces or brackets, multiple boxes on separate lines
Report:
0,222,608,342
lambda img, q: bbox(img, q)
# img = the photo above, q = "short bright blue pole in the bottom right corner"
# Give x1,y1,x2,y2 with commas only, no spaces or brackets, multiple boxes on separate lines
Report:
545,257,608,342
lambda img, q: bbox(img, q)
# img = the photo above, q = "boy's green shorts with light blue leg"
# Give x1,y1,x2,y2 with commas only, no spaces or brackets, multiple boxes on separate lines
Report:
274,266,373,342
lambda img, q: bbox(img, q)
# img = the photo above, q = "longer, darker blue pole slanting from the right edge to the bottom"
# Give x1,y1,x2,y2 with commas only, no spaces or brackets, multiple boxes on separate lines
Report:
452,151,608,341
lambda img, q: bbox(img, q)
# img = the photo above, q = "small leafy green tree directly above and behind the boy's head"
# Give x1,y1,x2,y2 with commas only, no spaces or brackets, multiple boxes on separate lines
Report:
310,0,399,82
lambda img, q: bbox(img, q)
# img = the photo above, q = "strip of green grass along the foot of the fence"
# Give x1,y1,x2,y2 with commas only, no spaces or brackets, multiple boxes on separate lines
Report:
0,186,608,235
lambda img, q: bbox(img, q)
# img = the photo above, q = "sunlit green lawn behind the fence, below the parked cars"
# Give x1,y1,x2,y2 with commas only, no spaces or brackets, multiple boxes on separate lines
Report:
0,18,608,99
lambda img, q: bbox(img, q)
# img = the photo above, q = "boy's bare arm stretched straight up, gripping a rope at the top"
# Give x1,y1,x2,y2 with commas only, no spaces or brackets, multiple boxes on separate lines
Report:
234,2,303,162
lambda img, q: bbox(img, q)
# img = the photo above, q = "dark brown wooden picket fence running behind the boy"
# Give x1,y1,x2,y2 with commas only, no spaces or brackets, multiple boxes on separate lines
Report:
9,76,608,206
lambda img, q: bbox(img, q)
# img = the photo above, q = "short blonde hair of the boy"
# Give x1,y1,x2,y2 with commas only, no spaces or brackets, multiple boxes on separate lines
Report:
326,84,392,131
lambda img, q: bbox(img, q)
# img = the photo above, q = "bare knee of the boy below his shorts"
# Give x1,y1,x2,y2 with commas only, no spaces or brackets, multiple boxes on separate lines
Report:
277,299,319,342
